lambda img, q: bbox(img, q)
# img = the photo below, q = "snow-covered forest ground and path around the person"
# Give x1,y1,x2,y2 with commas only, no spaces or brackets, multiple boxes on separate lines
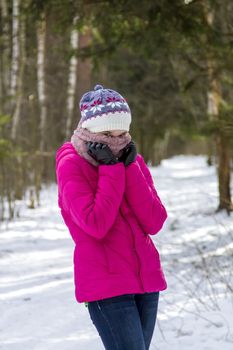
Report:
0,156,233,350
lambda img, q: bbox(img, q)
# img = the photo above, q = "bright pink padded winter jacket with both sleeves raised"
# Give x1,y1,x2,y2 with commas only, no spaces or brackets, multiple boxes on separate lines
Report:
56,141,167,303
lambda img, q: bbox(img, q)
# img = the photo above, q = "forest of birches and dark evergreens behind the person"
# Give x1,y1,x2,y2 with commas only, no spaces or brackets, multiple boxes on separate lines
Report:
0,0,233,221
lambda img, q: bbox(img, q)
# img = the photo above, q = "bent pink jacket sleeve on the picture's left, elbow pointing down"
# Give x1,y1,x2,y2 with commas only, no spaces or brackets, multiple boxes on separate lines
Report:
57,157,125,239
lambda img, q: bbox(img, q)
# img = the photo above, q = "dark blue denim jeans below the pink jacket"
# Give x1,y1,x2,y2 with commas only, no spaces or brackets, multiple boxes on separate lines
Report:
88,292,159,350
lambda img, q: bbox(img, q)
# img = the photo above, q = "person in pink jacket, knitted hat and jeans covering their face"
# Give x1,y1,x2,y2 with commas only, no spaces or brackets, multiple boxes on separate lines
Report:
56,85,167,350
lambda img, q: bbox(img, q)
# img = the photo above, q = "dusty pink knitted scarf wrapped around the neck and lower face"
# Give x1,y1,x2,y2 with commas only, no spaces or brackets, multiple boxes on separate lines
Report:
70,126,131,166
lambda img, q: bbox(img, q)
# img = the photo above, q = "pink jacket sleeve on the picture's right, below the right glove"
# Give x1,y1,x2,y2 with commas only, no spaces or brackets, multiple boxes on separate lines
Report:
125,154,167,235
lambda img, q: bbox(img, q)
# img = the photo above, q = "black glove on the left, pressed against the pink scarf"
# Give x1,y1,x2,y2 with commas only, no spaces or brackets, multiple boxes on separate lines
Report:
87,141,119,165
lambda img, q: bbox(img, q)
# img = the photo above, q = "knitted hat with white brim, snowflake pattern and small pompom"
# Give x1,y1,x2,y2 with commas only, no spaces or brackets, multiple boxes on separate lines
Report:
78,85,131,132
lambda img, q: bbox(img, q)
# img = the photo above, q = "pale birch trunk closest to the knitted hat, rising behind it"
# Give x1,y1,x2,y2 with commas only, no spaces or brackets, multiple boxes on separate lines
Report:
65,16,79,138
